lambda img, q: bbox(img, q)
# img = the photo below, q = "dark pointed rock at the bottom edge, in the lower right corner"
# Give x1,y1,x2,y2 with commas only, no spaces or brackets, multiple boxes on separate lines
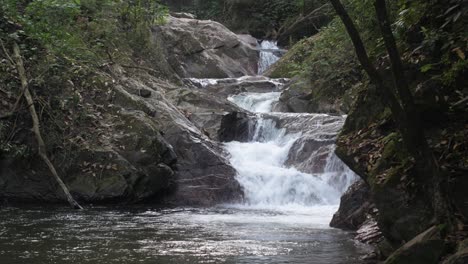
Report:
385,226,445,264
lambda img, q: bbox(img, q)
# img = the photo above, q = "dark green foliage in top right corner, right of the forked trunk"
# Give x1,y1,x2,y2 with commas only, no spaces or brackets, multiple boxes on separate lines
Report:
395,0,468,86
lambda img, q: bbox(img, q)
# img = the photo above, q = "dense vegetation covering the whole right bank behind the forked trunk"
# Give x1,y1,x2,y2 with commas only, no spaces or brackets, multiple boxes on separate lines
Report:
270,0,468,263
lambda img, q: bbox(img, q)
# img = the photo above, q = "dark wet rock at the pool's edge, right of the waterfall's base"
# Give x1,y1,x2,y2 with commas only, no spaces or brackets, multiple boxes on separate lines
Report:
330,180,372,230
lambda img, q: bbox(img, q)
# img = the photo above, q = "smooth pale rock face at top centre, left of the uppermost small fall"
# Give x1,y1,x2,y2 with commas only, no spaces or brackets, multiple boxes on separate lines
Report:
153,16,259,78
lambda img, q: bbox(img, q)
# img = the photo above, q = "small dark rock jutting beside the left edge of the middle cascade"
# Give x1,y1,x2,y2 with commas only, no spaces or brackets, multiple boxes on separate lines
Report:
219,112,255,142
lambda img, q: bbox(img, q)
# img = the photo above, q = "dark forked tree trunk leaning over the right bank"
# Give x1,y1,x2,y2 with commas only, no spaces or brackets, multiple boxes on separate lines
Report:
330,0,450,225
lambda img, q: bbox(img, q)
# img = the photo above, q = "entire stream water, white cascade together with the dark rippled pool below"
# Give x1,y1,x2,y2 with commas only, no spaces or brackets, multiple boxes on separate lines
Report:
0,40,366,264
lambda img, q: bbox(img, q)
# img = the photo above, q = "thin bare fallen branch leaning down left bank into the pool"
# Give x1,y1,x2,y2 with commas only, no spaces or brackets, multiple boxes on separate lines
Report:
13,42,83,209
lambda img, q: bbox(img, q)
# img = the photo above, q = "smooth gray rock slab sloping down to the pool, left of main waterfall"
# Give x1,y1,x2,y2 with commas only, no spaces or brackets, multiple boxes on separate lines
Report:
110,75,242,205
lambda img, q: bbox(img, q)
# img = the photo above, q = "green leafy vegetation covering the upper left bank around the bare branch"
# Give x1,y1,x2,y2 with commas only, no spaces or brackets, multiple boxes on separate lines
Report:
0,0,168,160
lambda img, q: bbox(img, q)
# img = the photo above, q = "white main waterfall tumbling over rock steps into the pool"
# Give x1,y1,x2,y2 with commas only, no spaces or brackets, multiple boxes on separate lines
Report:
225,92,354,208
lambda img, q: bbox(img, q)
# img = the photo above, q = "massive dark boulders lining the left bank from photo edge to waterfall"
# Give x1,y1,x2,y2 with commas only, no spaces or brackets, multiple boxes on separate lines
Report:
0,67,242,205
